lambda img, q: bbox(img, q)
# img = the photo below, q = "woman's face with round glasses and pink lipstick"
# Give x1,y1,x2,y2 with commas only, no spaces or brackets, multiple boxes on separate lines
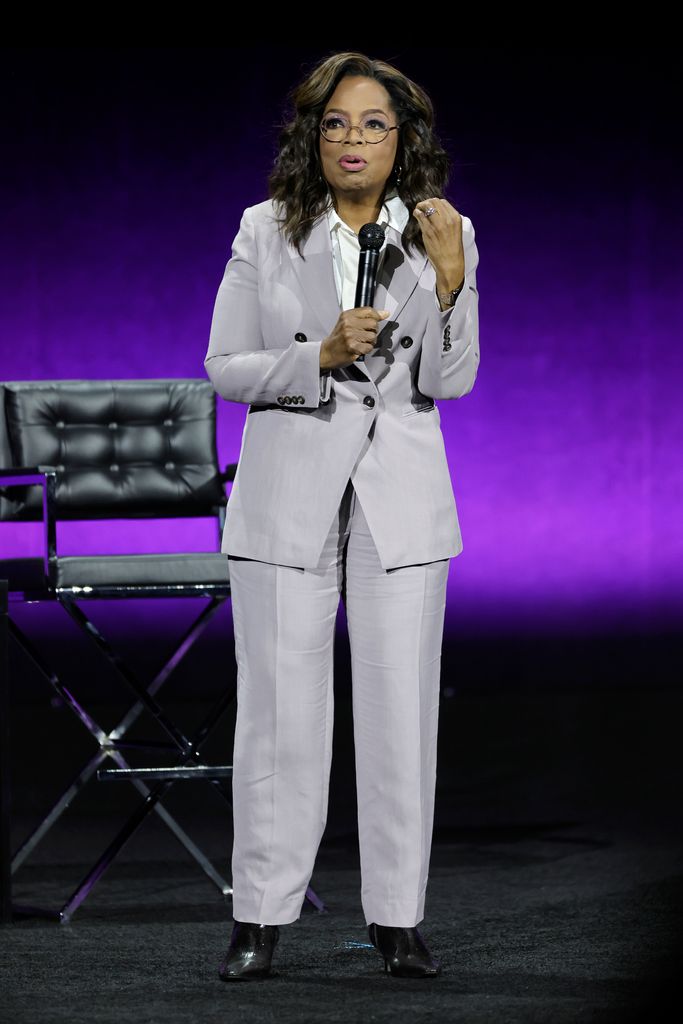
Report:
319,75,398,203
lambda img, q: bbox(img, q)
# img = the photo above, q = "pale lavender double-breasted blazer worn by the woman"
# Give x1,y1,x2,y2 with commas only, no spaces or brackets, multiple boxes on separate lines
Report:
204,200,479,569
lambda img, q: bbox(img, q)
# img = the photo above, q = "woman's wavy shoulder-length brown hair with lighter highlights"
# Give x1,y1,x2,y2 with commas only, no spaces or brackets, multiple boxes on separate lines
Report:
268,51,451,255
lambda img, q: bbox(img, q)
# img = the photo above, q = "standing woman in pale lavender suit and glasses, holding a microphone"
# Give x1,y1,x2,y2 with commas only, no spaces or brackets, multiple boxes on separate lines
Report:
205,53,479,981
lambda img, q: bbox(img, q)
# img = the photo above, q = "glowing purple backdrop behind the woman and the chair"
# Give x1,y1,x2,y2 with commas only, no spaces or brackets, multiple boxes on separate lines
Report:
0,51,683,633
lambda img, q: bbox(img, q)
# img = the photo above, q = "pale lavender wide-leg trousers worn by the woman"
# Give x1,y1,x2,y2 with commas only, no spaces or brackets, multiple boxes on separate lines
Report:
228,479,450,928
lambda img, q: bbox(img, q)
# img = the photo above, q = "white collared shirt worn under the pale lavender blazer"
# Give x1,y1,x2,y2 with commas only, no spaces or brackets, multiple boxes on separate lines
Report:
321,189,410,401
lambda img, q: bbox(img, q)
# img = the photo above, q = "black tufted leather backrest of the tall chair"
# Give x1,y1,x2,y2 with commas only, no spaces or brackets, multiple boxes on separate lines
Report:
0,378,225,521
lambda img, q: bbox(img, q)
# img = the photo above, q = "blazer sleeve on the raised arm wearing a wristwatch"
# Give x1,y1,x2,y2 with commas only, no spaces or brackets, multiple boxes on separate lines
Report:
418,216,479,398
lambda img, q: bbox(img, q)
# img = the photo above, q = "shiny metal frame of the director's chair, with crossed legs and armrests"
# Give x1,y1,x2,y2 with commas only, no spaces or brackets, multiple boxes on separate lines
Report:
0,382,327,924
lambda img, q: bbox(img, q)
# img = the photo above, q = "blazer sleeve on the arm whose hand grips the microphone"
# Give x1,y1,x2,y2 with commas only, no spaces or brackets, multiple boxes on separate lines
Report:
204,207,330,408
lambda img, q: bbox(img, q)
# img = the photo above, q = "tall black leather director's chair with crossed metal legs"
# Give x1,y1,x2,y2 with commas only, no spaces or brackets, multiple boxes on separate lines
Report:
0,379,326,923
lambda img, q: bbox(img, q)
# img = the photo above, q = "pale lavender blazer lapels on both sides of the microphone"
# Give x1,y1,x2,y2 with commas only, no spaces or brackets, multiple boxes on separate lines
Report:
287,213,428,381
